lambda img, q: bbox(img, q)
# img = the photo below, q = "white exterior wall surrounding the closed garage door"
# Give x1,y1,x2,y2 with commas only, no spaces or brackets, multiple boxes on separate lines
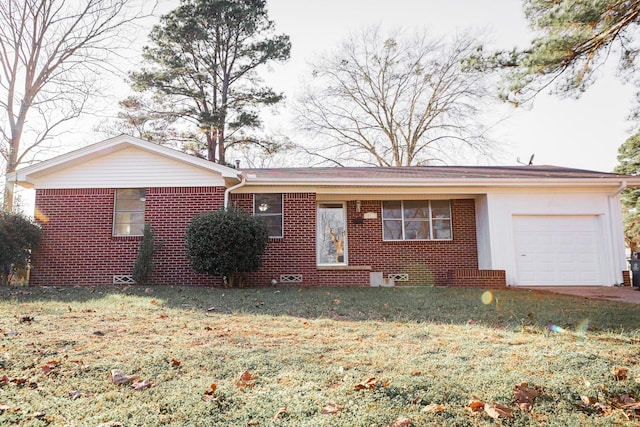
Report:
476,189,627,286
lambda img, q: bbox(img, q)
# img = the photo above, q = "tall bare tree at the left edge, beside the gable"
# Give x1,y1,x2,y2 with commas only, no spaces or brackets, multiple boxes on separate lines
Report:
0,0,153,211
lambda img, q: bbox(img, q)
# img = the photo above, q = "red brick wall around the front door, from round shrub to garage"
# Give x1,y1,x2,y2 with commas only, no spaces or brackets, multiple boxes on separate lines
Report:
231,193,478,286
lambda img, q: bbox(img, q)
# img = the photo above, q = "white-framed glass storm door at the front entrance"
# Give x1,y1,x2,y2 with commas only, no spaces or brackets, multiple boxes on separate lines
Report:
316,203,347,265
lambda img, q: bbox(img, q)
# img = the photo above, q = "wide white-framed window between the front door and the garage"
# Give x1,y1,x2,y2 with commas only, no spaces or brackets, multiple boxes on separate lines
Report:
382,200,453,240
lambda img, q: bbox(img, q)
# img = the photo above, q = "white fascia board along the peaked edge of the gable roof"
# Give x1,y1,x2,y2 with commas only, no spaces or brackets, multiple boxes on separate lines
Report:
7,135,240,188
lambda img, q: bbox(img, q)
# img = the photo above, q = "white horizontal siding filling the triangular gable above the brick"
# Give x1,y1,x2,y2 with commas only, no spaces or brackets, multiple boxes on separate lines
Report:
26,147,225,189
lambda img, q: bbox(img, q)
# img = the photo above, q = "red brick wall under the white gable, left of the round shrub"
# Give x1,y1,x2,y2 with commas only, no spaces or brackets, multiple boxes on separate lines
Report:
30,187,224,285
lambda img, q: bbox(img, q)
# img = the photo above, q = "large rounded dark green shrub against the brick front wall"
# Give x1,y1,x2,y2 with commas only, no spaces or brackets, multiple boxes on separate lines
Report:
186,208,269,287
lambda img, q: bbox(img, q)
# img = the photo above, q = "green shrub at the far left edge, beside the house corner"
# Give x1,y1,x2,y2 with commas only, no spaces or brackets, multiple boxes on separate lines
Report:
0,212,41,286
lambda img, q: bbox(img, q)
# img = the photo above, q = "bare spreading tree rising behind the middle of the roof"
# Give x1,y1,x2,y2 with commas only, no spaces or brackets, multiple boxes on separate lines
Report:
296,27,498,166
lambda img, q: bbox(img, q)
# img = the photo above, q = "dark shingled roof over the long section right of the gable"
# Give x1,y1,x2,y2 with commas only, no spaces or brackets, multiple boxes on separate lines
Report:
242,165,628,181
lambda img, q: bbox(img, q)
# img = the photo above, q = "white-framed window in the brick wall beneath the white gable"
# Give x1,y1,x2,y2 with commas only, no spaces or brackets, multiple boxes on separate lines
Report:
113,188,147,236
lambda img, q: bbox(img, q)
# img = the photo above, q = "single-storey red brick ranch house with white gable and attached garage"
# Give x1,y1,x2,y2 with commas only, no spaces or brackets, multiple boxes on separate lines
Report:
10,135,640,286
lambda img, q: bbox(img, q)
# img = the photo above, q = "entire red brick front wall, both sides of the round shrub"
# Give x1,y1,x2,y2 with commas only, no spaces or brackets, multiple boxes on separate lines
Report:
31,187,478,286
